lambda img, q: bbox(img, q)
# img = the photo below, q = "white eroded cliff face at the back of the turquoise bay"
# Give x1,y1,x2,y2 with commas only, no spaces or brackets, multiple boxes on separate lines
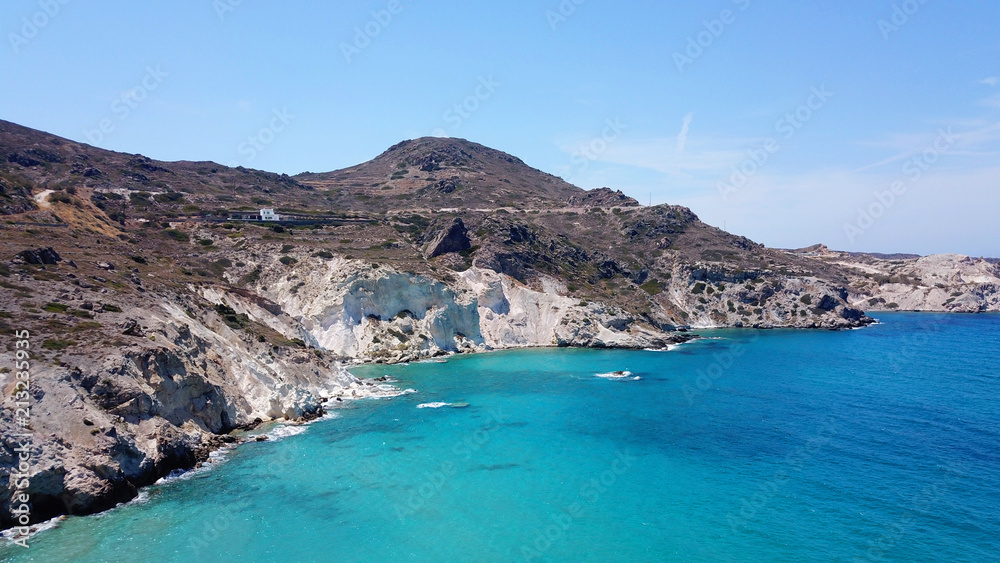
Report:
214,249,688,362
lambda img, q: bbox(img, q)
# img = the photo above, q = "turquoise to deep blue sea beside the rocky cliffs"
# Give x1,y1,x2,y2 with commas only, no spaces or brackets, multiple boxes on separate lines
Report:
0,313,1000,563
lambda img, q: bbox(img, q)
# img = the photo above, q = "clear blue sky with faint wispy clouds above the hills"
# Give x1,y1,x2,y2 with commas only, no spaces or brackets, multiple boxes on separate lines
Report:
0,0,1000,256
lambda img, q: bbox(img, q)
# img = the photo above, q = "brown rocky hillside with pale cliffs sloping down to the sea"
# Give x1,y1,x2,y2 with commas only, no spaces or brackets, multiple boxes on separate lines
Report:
0,118,892,527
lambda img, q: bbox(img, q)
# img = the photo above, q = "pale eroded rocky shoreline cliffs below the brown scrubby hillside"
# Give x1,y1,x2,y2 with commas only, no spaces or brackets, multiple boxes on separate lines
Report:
0,242,872,528
